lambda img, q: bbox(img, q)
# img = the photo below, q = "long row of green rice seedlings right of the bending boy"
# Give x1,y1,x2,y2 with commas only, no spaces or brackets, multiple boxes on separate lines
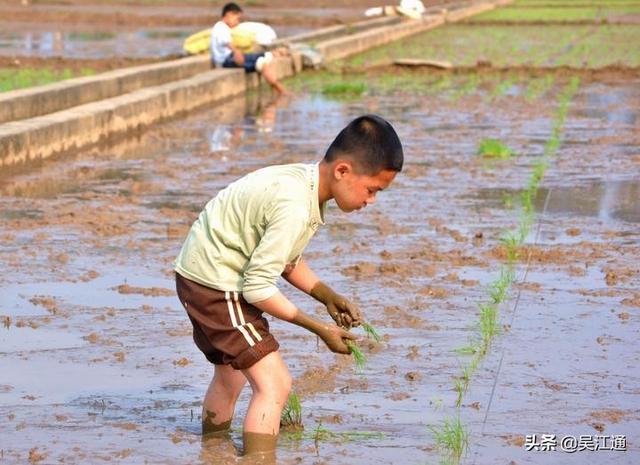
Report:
430,78,579,463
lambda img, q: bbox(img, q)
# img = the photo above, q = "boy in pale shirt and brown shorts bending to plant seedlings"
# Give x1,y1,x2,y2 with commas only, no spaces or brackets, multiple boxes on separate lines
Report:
175,115,403,454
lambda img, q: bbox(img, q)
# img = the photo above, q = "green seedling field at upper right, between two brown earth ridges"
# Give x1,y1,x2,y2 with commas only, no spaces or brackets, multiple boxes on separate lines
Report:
344,23,640,68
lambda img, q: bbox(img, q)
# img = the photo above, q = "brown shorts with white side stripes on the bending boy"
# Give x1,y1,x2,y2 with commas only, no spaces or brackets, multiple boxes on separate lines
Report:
176,273,279,370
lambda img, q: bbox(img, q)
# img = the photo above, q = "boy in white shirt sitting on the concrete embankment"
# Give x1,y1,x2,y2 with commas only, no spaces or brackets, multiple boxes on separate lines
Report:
211,3,288,95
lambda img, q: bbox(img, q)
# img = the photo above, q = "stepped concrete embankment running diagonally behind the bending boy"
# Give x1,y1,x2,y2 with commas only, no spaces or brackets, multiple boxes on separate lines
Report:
0,0,508,168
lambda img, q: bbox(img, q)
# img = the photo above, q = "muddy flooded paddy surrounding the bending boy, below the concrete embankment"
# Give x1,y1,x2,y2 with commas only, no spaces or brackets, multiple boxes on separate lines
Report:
0,78,640,464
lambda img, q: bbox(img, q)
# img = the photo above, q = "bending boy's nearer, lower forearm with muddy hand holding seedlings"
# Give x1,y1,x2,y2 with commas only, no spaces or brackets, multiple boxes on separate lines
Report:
253,291,355,354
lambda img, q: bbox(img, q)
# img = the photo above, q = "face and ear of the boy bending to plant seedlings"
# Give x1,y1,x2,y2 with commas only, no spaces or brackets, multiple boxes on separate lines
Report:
331,161,397,213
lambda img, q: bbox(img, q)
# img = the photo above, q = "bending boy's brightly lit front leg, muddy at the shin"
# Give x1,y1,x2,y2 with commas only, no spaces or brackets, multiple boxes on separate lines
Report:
242,351,291,454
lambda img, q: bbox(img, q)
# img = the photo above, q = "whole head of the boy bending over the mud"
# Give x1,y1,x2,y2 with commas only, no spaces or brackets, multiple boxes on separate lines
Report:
322,115,404,212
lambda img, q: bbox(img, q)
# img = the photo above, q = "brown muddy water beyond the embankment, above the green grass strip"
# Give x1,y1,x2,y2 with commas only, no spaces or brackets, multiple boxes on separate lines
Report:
0,3,364,59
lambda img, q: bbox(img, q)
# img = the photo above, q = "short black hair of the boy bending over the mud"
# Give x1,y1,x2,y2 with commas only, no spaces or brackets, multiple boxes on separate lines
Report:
324,115,404,175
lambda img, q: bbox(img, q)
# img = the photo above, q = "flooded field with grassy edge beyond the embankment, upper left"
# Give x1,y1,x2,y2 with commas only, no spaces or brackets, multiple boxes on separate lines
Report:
0,0,375,92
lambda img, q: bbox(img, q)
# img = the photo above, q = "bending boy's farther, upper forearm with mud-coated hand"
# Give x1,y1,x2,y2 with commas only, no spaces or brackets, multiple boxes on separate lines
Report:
282,258,362,329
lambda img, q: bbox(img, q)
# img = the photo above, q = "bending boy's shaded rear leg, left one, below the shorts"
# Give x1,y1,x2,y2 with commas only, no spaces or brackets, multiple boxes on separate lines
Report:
202,365,247,434
